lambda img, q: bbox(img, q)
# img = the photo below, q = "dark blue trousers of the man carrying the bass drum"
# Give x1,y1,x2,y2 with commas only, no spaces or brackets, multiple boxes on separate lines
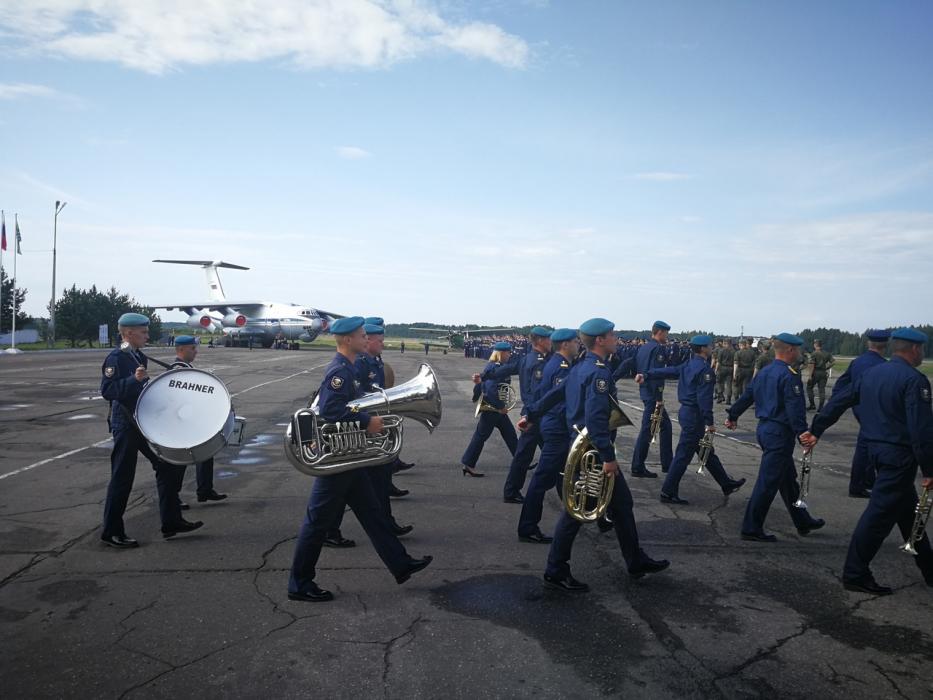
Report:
101,425,185,537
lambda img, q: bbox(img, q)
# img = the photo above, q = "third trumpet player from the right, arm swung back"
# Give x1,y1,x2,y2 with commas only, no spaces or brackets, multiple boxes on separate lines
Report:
635,335,745,505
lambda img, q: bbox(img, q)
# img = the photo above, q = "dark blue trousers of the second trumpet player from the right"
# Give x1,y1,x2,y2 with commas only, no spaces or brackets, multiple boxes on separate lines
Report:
742,421,813,535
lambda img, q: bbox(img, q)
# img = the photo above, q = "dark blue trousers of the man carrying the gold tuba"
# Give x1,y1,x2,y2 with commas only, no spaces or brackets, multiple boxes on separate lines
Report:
544,472,647,578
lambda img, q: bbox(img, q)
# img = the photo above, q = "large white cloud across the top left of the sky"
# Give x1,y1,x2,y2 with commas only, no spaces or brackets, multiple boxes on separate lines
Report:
0,0,529,74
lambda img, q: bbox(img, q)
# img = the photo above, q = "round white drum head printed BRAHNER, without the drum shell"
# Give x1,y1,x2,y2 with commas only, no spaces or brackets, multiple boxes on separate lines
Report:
136,369,231,449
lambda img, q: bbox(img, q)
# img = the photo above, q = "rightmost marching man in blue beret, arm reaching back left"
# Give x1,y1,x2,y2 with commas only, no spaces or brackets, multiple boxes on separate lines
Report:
810,328,933,595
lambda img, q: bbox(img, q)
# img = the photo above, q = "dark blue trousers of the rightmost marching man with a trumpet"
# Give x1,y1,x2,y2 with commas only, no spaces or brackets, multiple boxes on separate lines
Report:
842,452,933,581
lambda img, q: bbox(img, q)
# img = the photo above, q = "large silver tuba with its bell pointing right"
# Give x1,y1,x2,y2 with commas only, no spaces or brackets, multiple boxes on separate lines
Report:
284,364,441,476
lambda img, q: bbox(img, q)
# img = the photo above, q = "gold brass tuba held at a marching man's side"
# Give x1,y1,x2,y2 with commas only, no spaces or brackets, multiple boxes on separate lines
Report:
563,396,632,523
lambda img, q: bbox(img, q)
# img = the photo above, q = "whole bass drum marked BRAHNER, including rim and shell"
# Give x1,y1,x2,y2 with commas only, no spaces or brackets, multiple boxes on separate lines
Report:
135,369,242,465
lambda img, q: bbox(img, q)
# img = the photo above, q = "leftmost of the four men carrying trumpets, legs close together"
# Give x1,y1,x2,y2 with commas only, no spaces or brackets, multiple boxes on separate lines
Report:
632,321,674,479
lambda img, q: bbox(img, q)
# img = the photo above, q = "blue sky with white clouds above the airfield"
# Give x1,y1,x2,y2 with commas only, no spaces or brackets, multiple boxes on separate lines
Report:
0,0,933,334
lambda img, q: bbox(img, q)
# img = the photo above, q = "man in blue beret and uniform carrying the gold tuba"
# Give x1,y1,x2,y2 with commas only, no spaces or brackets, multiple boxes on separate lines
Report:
544,318,670,593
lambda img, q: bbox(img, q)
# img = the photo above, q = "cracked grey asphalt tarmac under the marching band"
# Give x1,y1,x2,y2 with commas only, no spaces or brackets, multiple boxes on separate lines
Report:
0,348,933,699
